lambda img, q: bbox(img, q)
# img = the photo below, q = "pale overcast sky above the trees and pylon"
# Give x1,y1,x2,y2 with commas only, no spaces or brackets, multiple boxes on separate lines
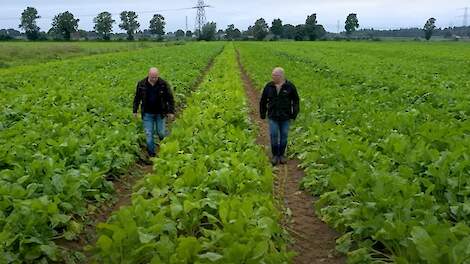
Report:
0,0,470,32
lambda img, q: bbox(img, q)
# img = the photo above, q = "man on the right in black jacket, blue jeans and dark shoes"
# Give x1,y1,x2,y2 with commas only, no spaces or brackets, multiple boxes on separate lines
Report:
259,67,299,166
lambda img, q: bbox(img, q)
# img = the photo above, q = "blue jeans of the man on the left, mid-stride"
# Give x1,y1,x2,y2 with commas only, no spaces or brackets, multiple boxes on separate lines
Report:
142,113,167,156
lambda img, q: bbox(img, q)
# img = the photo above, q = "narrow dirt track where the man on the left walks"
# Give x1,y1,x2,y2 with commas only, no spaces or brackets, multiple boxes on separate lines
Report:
54,49,223,263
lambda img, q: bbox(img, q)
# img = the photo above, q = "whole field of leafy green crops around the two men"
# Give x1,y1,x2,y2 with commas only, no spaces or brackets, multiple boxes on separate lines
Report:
0,42,470,264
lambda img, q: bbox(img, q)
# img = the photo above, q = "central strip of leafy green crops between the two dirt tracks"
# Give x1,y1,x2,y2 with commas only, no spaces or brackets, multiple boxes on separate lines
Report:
90,45,291,263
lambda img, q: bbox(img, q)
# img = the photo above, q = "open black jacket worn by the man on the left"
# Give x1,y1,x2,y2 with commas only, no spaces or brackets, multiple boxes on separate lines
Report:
132,78,175,115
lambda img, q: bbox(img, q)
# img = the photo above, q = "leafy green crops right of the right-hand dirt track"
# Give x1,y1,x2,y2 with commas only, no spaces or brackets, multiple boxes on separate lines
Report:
238,42,470,263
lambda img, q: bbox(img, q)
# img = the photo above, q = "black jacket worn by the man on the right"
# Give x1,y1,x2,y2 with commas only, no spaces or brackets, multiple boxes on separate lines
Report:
259,80,299,121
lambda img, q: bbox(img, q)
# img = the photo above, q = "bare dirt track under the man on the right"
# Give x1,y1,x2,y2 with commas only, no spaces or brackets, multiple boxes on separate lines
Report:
237,50,345,264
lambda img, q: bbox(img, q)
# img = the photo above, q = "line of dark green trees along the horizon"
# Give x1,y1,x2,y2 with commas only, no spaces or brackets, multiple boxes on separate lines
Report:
0,7,456,41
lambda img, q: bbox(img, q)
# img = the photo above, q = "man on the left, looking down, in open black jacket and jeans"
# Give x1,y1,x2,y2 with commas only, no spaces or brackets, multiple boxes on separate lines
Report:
133,68,175,157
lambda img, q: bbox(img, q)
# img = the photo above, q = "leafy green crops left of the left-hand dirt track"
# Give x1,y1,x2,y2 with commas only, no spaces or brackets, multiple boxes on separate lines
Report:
0,43,221,263
